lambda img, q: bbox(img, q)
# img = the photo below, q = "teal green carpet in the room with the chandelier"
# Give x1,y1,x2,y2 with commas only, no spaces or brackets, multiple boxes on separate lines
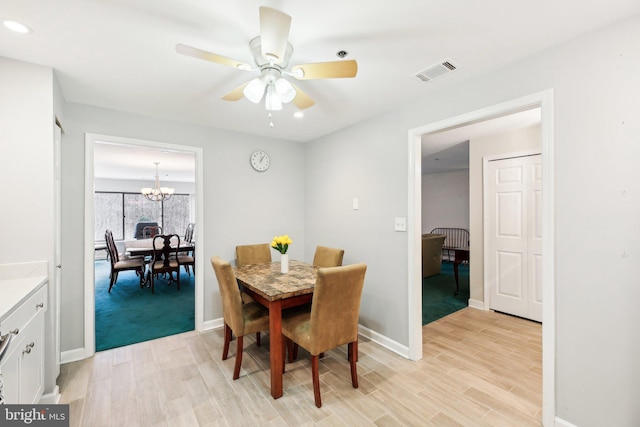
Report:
95,260,195,351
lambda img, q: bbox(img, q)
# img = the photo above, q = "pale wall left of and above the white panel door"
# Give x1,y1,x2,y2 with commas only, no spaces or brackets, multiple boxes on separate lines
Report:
469,125,541,301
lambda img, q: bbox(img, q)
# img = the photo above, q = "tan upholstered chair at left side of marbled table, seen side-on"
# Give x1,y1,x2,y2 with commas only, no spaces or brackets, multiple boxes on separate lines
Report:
211,256,269,380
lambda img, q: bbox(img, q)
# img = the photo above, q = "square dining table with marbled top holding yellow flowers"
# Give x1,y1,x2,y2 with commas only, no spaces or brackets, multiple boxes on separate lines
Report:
234,260,318,399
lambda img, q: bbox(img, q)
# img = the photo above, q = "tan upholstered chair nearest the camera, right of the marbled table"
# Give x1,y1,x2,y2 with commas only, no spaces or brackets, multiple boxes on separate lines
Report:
282,264,367,408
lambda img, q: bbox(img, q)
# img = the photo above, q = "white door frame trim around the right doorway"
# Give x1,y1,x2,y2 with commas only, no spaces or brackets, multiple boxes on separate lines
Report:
408,90,555,424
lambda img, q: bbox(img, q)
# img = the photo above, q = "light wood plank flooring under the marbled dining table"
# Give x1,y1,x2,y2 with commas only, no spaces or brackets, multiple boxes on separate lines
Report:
58,308,542,427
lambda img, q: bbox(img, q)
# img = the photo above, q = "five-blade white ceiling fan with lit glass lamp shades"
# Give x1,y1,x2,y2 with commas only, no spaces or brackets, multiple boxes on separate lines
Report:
176,6,358,111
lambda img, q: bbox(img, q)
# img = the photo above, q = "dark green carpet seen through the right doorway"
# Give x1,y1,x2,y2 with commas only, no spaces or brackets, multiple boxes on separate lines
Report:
422,262,469,325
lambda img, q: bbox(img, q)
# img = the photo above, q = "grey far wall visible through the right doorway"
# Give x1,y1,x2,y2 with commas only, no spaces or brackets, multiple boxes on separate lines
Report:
422,169,469,234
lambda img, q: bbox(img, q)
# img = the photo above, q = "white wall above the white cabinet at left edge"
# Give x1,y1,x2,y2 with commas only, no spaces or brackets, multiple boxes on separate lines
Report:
0,57,61,402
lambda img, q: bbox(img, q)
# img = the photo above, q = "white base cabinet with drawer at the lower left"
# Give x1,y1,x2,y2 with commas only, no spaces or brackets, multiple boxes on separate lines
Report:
0,281,47,404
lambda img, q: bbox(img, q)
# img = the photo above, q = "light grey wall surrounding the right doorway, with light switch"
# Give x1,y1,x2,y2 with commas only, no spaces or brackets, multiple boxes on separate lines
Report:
305,16,640,427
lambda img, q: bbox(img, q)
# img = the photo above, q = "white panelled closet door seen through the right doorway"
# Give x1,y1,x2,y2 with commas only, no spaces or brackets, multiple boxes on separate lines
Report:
485,154,542,322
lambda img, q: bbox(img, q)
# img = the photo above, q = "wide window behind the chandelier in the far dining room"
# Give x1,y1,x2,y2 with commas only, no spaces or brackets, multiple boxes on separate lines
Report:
94,191,191,241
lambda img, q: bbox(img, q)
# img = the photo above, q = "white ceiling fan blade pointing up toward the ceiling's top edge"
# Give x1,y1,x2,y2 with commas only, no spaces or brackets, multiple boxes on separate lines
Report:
260,6,291,64
